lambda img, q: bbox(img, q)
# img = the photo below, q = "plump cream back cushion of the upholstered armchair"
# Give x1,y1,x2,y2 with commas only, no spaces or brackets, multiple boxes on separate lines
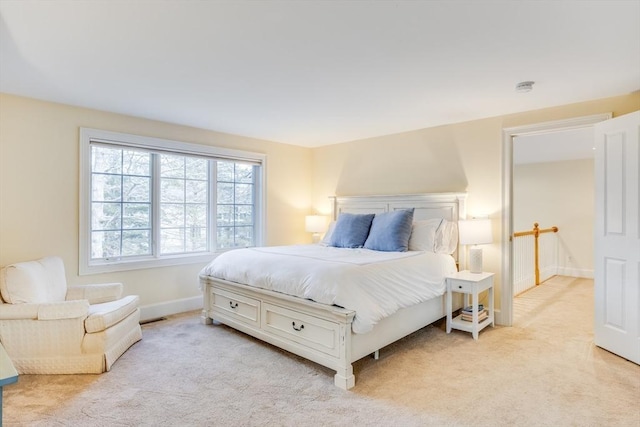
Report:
0,257,67,304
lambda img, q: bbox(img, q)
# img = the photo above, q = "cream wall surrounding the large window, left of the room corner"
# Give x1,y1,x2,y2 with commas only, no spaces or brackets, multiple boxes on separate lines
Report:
0,94,312,320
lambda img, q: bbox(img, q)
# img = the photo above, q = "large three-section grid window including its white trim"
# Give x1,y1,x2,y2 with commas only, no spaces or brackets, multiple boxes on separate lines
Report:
80,128,265,274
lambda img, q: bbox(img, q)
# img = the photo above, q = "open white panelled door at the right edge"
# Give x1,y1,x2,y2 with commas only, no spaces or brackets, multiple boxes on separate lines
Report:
594,111,640,364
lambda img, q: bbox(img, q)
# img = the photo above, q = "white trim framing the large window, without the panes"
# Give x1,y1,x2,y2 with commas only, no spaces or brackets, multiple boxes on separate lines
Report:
79,128,267,275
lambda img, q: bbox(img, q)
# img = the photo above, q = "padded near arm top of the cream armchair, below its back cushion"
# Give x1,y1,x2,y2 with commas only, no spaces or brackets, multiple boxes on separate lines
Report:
0,300,89,320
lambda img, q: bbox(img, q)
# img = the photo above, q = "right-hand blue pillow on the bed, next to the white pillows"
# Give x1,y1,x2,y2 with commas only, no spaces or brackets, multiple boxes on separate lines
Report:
364,209,413,252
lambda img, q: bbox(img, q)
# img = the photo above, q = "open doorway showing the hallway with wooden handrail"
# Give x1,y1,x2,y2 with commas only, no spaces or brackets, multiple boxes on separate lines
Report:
512,127,595,326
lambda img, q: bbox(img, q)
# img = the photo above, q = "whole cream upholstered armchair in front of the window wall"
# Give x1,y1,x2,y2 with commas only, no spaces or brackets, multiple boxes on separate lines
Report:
0,257,142,374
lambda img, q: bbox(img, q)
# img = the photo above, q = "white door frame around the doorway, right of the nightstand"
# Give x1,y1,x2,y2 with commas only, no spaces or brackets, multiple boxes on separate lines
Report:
496,113,613,326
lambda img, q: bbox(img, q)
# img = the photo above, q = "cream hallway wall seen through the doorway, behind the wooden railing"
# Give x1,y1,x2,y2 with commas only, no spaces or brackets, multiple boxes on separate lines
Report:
513,159,595,277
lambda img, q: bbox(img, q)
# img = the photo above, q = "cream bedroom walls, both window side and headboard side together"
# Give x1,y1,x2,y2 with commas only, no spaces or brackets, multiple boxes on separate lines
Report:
0,93,640,320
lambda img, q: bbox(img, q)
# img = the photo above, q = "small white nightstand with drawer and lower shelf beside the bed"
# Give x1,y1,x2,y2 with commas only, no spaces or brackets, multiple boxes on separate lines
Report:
446,270,495,340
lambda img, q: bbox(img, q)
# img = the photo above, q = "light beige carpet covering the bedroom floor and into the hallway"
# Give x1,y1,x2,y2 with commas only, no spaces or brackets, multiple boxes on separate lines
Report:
4,277,640,427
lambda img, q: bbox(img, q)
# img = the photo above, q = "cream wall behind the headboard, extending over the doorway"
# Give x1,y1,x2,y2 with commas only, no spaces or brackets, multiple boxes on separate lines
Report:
312,92,640,314
